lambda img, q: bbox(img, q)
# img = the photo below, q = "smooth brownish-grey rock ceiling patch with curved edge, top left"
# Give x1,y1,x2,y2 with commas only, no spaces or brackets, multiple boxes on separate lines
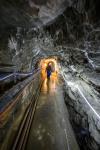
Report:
0,0,70,28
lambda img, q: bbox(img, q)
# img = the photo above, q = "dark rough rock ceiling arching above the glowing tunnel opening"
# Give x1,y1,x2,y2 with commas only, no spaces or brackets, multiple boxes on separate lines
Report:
0,0,100,71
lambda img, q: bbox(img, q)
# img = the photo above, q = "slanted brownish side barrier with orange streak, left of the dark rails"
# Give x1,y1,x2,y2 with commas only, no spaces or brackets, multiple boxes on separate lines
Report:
0,71,41,150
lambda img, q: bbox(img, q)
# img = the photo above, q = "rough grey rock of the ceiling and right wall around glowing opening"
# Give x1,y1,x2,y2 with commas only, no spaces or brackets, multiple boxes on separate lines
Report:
0,0,100,150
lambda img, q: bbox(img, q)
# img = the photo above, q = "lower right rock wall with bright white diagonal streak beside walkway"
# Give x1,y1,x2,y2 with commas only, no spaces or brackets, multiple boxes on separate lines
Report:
63,72,100,150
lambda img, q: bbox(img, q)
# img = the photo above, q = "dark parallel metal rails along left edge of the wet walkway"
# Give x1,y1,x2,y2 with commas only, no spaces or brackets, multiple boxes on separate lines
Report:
12,81,43,150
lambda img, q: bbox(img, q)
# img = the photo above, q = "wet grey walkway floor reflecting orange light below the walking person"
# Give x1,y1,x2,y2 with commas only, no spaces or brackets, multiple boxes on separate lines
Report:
26,78,79,150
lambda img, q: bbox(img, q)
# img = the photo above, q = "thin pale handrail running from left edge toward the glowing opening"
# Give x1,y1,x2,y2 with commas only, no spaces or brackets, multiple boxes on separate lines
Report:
0,69,40,81
